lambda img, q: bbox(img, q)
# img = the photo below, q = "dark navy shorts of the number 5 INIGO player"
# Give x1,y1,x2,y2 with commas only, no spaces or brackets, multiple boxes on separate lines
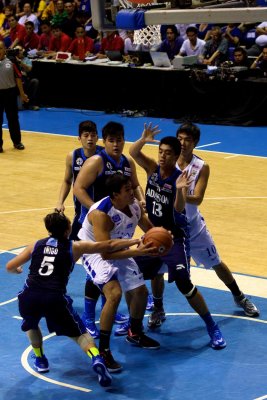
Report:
18,287,86,337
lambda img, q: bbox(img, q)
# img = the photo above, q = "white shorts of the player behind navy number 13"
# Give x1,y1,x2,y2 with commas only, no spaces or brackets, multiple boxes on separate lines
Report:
190,226,221,269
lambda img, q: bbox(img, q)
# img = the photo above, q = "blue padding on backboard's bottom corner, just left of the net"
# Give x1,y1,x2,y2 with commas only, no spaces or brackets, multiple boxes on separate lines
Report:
116,9,146,30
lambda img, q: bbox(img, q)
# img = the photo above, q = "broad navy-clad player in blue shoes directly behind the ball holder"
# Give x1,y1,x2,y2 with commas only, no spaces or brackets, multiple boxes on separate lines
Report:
73,121,145,338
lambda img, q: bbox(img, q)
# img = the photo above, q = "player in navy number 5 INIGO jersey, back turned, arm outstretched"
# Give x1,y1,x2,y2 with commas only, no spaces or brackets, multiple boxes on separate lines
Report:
6,212,140,386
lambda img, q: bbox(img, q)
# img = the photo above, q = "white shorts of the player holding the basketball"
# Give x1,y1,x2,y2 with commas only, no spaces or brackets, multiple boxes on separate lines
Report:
82,254,145,292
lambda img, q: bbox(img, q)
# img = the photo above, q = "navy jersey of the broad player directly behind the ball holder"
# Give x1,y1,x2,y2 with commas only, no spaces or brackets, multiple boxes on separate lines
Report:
79,150,132,223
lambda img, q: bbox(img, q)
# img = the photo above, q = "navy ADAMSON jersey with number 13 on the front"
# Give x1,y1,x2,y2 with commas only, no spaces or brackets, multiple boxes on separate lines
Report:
146,166,188,238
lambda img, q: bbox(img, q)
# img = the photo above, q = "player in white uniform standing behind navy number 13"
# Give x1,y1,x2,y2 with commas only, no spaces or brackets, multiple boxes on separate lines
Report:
176,123,259,317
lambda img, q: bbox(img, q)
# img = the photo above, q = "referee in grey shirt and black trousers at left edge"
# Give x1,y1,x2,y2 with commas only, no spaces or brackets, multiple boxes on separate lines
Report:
0,41,29,153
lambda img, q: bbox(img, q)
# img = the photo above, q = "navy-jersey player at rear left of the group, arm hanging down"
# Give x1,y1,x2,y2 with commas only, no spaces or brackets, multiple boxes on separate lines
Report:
56,121,103,240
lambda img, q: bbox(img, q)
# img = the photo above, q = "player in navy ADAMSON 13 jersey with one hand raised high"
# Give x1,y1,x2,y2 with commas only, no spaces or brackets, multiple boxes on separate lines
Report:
129,124,226,349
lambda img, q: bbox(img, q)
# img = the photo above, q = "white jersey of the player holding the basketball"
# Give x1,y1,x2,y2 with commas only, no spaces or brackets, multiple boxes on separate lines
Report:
79,196,141,241
